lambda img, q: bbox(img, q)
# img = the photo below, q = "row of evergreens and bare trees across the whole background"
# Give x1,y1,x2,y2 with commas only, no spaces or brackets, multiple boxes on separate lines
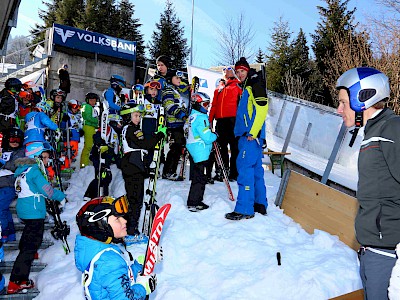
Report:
13,0,400,113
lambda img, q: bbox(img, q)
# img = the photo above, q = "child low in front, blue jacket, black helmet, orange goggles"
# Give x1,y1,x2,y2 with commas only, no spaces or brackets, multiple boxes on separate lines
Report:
75,196,158,300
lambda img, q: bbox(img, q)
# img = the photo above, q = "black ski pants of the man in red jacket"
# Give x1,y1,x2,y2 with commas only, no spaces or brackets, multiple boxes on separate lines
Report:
215,117,239,179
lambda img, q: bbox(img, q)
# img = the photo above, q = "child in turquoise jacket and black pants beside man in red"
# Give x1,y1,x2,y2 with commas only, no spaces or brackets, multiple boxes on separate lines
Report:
186,92,217,212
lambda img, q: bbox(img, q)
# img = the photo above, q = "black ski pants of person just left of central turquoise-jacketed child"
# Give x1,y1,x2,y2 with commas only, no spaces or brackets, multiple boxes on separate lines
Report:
163,127,186,175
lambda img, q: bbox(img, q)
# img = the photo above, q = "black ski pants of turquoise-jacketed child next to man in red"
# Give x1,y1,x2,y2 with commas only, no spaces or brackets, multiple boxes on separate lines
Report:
187,161,208,206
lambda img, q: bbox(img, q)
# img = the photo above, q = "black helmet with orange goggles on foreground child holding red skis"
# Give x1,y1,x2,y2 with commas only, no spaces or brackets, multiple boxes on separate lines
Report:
76,195,128,244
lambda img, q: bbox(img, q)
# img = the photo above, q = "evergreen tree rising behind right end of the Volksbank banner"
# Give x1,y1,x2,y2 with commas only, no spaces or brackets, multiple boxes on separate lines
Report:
116,0,145,66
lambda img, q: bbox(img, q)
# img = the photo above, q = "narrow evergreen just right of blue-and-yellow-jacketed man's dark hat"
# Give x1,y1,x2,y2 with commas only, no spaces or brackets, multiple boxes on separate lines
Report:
266,18,291,93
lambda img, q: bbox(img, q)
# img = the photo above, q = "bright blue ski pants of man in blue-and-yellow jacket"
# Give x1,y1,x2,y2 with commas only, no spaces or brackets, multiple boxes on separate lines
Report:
235,136,268,215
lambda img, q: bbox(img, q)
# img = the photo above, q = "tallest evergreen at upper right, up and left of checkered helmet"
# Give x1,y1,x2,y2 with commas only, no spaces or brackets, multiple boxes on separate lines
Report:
311,0,356,105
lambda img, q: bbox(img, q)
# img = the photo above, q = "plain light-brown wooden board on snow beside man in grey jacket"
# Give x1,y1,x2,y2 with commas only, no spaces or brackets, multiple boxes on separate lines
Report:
275,170,364,300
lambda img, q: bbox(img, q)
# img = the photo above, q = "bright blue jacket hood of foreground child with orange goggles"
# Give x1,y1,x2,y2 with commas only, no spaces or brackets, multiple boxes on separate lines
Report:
75,234,121,272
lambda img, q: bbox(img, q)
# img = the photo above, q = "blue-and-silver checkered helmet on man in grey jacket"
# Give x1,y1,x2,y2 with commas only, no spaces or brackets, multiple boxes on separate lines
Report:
336,67,390,113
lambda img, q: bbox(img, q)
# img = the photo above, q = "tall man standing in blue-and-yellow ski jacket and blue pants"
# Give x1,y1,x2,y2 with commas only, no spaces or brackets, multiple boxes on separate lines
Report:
225,57,268,220
